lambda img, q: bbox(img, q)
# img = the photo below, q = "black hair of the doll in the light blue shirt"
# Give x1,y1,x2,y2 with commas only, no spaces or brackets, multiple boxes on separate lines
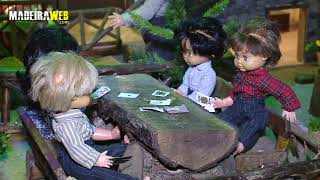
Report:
176,17,226,59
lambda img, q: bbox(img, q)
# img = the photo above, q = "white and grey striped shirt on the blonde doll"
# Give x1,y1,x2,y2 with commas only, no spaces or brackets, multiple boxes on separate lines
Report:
52,109,100,169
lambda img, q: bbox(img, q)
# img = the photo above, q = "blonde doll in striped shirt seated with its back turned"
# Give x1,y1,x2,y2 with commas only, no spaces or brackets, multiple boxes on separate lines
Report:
29,52,141,179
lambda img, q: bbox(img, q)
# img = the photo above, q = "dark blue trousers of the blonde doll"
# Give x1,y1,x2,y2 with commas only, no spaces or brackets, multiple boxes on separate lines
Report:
58,140,136,180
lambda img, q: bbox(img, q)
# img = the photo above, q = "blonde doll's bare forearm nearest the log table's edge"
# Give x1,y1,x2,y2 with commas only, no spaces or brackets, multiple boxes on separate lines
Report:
92,126,120,141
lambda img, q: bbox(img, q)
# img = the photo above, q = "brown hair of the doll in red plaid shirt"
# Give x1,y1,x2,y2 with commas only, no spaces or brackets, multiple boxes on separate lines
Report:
227,19,281,66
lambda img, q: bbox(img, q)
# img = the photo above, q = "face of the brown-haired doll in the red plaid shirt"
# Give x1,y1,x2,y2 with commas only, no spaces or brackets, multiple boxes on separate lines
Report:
234,51,267,72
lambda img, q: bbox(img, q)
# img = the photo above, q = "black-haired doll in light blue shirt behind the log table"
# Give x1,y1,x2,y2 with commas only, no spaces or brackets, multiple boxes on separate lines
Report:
175,17,226,101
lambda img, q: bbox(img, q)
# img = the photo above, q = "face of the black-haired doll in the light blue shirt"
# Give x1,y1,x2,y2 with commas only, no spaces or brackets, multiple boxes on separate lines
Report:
182,39,209,66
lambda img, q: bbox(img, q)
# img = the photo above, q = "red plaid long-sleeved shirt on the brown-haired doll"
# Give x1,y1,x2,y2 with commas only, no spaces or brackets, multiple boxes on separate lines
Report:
230,68,300,112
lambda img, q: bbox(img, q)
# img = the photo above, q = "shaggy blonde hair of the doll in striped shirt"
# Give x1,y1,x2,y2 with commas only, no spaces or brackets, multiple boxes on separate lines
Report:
29,52,98,112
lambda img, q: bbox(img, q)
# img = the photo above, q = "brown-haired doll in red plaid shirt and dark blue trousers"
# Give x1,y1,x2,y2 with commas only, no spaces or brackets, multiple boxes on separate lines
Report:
212,20,300,155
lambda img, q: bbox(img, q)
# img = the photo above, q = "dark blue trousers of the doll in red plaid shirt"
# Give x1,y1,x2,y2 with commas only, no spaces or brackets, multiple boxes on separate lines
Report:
218,96,269,151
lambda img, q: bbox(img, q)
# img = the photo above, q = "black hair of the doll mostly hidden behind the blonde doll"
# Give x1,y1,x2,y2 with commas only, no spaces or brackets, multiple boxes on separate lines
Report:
22,27,80,93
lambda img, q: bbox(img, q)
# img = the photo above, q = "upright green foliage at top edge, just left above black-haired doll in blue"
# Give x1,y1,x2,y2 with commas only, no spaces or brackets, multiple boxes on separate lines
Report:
165,0,187,30
